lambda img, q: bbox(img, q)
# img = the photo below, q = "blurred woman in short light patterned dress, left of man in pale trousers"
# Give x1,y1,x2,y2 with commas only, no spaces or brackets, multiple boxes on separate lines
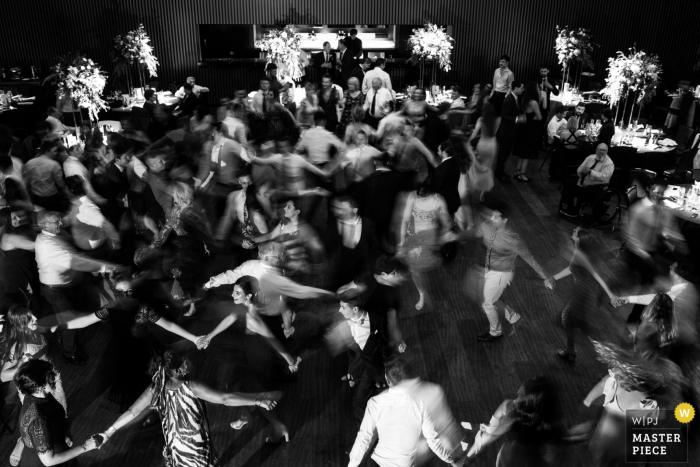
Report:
397,182,452,310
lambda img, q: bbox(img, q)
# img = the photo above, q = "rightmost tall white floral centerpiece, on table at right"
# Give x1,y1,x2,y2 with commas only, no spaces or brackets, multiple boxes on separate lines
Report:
601,47,663,123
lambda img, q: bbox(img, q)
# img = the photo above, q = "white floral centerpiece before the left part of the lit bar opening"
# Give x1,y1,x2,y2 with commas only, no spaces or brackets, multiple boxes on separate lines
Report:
255,24,304,81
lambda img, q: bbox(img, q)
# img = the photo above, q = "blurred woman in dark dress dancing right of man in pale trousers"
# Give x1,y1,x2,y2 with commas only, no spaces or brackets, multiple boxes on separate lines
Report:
554,227,614,361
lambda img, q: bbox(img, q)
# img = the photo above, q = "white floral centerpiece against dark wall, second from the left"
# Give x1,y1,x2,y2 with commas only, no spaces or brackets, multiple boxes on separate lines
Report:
111,24,159,94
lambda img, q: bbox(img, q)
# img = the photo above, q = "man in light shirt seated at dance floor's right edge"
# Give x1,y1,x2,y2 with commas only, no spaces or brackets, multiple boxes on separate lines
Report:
559,143,615,217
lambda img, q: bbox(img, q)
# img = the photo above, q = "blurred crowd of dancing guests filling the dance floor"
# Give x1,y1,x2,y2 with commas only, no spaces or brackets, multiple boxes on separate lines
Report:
0,49,697,467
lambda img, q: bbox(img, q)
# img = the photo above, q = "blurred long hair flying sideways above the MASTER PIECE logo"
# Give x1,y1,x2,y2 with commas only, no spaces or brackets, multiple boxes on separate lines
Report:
593,341,667,394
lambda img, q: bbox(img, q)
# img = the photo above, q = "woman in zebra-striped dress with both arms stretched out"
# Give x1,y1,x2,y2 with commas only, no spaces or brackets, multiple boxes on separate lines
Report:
98,352,281,467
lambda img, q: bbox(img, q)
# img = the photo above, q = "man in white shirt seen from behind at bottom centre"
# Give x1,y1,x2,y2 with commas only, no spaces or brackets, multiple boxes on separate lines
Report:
348,359,461,467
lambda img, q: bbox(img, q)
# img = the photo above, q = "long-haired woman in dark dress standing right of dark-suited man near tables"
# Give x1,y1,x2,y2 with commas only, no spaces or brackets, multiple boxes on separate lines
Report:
513,81,542,182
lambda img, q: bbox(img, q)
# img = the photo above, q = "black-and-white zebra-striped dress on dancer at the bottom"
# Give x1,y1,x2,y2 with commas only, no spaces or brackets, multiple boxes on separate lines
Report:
157,381,219,467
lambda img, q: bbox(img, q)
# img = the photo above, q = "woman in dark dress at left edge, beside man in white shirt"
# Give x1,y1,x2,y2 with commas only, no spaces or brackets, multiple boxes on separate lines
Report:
0,209,41,312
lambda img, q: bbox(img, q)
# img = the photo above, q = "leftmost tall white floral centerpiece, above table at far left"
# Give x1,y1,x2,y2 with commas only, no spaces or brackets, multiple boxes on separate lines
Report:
45,53,107,126
